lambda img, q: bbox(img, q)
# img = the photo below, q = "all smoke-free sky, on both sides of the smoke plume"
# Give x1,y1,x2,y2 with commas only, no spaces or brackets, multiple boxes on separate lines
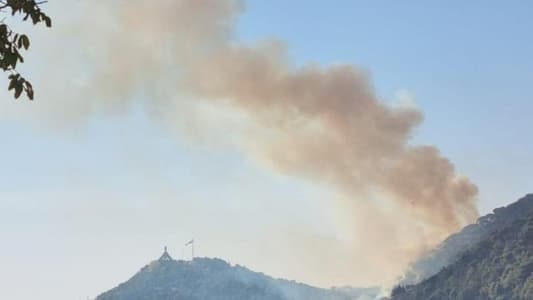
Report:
0,0,533,300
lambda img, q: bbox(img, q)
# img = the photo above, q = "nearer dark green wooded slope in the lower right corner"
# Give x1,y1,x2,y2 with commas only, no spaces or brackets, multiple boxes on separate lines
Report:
392,206,533,300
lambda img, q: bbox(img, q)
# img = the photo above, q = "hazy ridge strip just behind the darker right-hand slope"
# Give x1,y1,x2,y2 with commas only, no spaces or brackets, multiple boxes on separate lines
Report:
399,194,533,285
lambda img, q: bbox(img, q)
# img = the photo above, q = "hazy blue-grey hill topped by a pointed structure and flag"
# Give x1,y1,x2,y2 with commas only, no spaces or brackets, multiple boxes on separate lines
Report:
96,251,380,300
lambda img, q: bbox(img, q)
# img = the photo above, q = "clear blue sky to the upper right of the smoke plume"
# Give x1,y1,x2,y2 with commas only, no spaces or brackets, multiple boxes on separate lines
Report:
239,0,533,213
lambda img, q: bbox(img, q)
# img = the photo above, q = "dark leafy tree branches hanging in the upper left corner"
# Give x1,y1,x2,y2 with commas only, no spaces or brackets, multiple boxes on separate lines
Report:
0,0,52,100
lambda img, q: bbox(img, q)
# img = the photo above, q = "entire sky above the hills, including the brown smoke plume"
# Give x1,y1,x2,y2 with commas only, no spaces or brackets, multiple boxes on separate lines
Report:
0,0,533,300
